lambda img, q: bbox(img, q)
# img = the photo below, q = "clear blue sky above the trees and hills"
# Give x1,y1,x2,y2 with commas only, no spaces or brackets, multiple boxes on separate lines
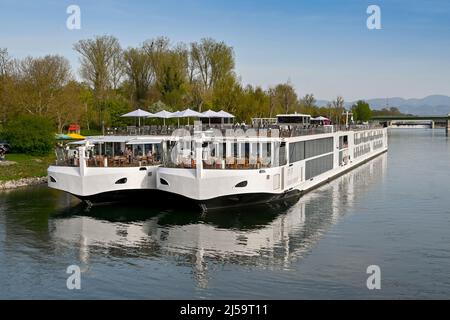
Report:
0,0,450,101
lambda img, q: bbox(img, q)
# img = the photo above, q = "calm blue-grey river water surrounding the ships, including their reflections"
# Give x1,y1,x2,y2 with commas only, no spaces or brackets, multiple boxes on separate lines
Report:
0,129,450,299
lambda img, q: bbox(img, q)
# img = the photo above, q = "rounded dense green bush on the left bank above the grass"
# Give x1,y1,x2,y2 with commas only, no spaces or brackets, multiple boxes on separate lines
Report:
2,115,55,155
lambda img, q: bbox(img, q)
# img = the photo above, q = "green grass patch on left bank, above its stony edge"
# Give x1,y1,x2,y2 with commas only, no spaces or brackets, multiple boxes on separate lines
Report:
0,153,55,182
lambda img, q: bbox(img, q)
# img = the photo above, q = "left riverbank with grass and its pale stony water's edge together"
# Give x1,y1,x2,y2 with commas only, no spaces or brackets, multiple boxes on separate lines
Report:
0,154,55,190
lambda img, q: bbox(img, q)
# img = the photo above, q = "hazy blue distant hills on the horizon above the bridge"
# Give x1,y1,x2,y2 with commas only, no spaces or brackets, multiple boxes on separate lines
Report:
317,95,450,115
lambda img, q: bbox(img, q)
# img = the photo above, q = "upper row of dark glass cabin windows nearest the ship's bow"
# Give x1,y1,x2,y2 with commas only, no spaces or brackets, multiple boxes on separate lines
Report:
289,138,333,163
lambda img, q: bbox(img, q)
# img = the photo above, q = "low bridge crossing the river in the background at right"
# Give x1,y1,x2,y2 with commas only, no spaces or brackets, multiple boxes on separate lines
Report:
372,114,450,136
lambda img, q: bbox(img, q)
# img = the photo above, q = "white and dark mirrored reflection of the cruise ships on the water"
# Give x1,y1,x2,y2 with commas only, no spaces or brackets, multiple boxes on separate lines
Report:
48,154,387,288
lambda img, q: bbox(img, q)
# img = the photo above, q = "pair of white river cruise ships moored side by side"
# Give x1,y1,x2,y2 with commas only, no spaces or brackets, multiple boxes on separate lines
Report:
48,114,388,210
